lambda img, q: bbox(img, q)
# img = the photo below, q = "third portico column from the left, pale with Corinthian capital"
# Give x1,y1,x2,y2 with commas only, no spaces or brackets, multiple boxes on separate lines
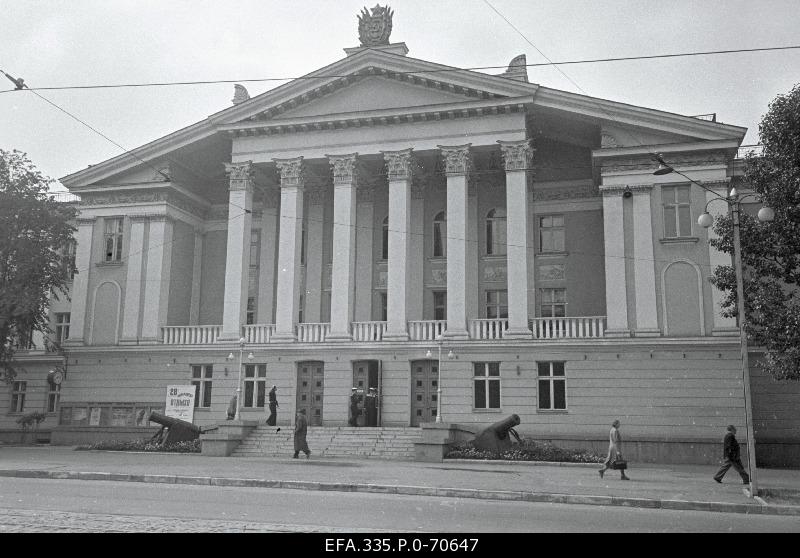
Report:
327,153,359,341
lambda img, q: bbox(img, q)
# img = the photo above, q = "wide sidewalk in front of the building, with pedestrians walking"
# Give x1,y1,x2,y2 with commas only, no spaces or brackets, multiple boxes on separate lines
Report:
0,446,800,516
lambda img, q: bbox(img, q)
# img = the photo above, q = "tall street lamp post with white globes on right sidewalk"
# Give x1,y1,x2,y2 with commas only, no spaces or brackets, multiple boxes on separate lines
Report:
653,155,775,498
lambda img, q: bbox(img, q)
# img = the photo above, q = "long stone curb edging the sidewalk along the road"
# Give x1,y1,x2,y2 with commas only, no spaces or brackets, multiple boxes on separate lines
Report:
0,469,800,516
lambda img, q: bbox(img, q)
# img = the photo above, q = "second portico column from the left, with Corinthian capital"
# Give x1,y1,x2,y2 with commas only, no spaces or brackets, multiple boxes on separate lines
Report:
273,157,305,341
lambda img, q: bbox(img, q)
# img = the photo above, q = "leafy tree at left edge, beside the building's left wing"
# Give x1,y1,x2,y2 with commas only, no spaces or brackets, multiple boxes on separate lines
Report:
0,149,76,382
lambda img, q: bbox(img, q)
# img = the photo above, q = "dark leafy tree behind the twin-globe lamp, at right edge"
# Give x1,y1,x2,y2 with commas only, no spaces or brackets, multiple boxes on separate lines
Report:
711,84,800,380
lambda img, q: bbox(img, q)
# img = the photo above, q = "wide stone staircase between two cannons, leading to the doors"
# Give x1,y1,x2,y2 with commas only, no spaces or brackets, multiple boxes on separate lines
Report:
232,424,422,460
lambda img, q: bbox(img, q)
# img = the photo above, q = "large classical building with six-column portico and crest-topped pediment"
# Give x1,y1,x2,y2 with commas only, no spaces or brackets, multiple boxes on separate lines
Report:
0,9,800,462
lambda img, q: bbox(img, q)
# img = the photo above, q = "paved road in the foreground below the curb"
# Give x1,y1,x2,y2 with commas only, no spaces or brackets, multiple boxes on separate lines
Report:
0,478,800,533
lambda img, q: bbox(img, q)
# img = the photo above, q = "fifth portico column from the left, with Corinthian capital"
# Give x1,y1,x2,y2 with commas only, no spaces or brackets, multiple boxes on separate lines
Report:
438,143,472,339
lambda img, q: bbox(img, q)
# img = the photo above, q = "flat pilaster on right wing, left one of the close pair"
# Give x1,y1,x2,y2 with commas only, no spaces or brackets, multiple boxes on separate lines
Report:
601,188,630,337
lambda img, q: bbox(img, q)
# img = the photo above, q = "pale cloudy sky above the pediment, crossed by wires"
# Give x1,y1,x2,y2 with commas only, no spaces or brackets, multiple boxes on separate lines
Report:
0,0,800,190
